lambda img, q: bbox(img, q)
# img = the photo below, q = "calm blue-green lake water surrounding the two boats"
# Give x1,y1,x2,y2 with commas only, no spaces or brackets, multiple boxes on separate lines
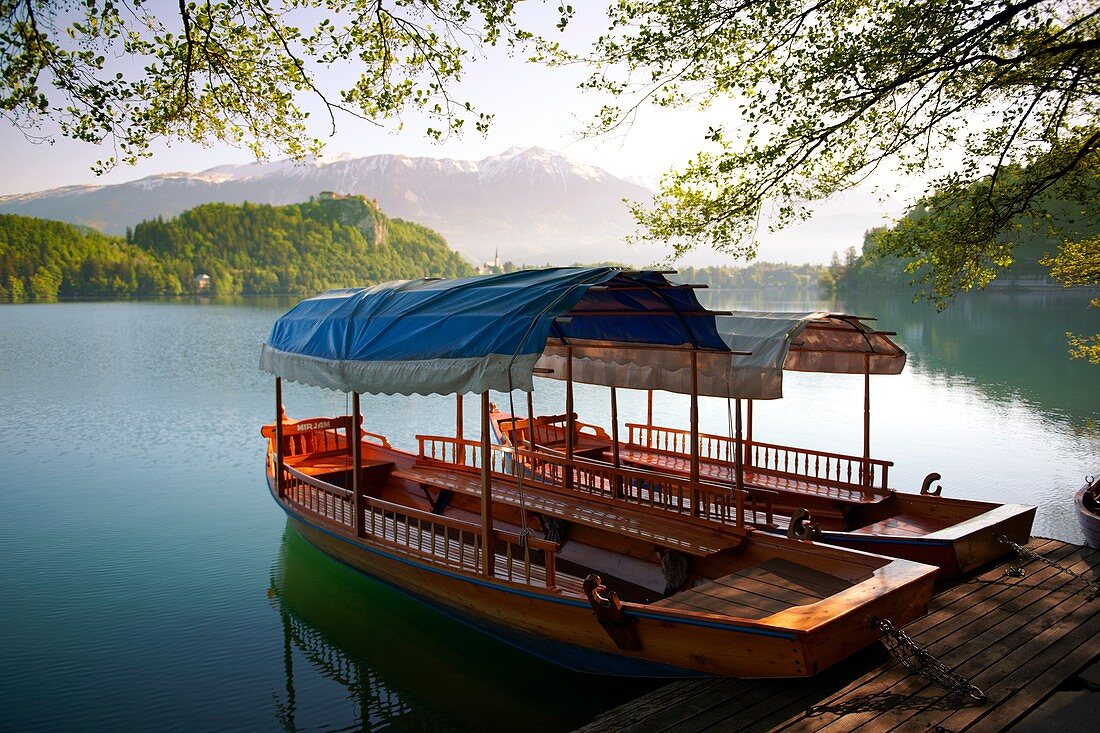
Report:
0,292,1100,731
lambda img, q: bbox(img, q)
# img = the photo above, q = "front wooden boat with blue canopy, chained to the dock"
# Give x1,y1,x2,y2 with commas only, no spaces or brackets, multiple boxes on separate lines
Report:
261,267,935,677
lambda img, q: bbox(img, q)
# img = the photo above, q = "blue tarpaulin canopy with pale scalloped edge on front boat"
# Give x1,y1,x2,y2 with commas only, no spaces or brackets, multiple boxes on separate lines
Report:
253,267,729,394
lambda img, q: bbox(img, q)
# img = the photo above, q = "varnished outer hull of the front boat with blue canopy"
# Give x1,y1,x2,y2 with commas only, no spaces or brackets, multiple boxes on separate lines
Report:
268,477,932,678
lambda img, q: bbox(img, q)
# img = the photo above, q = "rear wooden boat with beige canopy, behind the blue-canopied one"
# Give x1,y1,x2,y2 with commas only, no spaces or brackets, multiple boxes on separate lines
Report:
493,313,1035,577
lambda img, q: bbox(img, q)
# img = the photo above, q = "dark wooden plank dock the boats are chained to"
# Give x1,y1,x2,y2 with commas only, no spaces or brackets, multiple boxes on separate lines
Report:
581,538,1100,733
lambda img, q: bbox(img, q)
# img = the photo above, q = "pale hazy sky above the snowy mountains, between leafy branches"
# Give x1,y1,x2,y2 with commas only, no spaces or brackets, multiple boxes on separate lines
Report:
0,3,903,263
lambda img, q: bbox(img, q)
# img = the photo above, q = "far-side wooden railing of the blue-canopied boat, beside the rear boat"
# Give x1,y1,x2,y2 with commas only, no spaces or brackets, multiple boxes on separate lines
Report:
417,435,776,527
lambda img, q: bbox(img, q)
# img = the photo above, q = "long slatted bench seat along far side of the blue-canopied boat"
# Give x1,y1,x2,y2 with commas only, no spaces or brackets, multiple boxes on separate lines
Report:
393,466,741,557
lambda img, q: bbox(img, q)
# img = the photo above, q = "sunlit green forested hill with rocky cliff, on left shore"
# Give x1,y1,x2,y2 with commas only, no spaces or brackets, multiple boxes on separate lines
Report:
0,196,473,303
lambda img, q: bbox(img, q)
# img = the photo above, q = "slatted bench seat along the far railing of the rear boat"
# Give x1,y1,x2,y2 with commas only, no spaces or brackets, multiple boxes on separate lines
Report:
604,446,884,504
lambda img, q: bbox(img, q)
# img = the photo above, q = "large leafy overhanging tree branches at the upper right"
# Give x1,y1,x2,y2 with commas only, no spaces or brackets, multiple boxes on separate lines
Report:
563,0,1100,356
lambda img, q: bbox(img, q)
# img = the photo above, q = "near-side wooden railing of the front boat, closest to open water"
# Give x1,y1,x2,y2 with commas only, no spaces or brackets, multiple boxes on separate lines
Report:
283,467,558,590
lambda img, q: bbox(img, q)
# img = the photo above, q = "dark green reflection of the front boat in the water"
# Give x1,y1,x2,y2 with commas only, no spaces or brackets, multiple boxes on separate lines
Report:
270,526,655,731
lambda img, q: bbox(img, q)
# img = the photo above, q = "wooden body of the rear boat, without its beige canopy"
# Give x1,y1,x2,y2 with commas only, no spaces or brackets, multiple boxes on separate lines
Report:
494,413,1035,577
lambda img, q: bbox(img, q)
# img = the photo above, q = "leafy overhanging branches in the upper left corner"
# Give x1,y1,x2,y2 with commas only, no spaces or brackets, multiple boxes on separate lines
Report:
0,0,572,172
